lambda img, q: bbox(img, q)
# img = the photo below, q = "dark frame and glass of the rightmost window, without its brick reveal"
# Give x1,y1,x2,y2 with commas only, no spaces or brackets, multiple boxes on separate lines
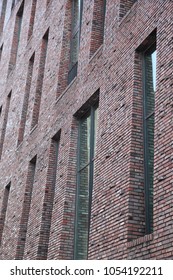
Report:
144,43,156,233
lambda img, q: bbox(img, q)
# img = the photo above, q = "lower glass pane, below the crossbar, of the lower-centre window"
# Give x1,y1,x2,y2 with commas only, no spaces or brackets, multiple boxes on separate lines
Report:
75,166,89,260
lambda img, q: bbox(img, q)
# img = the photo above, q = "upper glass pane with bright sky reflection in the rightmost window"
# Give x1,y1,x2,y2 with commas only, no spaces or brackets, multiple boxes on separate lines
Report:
145,50,156,117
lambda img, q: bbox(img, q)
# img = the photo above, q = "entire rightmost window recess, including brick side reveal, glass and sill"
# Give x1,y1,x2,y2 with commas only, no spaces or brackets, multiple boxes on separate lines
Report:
128,30,156,241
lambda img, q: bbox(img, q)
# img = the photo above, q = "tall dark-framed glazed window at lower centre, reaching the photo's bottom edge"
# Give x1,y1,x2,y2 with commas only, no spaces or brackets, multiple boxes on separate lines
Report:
74,106,98,259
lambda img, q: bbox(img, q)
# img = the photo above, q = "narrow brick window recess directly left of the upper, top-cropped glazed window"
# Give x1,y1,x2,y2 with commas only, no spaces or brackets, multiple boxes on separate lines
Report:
31,29,49,129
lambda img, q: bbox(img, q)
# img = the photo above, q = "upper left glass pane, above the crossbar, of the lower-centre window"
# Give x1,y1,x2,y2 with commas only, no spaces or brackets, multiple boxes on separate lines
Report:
79,115,91,170
